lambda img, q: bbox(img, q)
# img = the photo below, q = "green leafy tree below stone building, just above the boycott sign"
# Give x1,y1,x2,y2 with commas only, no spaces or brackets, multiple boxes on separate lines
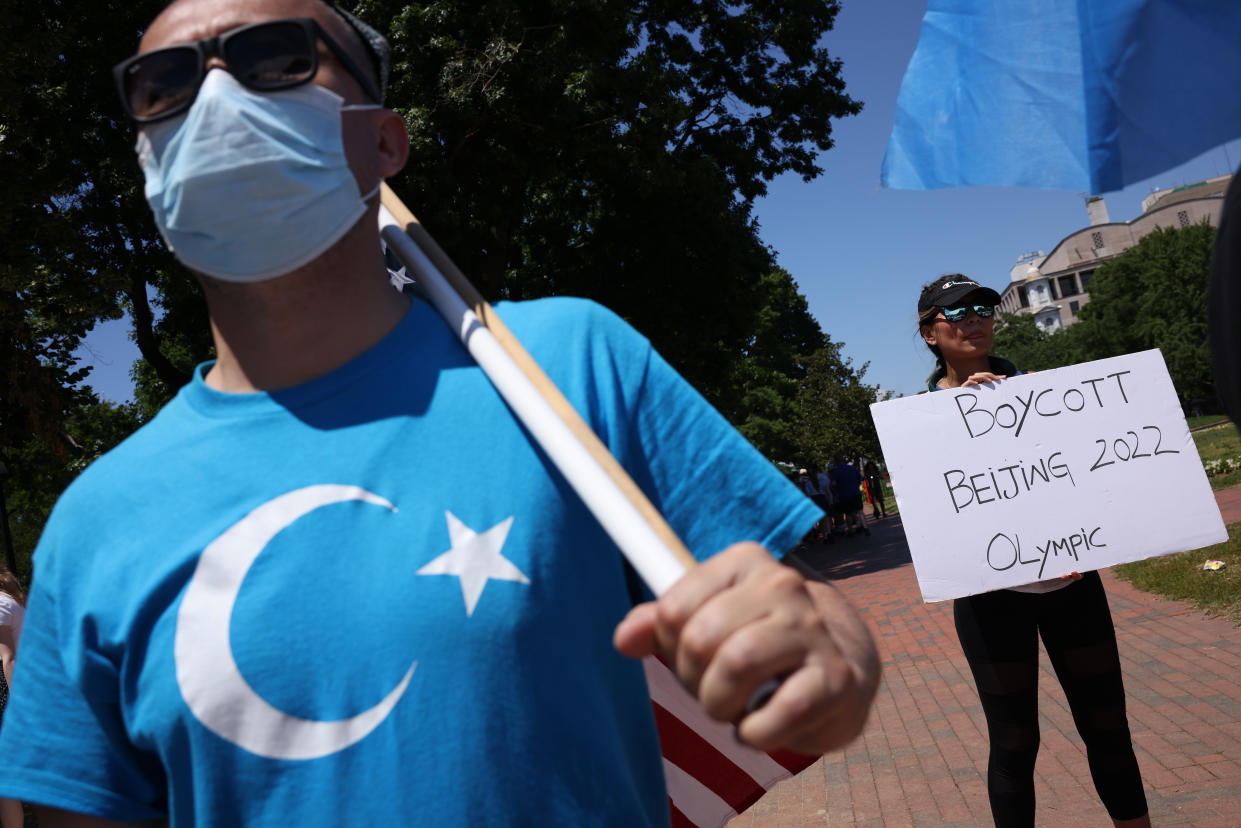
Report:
1070,222,1219,410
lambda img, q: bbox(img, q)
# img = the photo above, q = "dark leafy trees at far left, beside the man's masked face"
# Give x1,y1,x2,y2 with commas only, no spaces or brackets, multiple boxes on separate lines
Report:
0,0,190,583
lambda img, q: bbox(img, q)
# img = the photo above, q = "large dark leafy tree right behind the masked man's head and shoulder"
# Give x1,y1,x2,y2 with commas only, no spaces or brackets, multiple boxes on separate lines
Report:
357,0,860,408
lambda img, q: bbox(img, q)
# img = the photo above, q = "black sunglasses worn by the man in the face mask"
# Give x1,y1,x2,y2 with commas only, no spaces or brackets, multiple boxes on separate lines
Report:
112,17,380,124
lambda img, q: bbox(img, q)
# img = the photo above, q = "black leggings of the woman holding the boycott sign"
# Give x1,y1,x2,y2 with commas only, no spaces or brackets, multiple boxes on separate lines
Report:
953,572,1147,828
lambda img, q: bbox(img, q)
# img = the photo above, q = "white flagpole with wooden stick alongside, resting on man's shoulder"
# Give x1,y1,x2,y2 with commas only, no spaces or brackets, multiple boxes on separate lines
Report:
380,191,695,596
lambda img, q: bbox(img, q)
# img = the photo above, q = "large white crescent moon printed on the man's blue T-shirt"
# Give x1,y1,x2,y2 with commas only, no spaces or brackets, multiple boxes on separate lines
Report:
174,484,417,760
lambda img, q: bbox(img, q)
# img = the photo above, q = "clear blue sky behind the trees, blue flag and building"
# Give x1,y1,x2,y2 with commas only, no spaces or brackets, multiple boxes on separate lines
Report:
81,0,1241,401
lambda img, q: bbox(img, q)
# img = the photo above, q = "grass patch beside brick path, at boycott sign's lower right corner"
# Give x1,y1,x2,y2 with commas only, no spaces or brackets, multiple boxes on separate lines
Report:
1112,523,1241,623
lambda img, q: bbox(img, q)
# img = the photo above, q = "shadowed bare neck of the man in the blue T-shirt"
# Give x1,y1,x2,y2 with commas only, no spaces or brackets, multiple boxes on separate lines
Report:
204,214,410,394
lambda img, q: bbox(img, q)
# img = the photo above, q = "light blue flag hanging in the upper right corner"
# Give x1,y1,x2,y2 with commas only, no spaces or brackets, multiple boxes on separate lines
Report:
881,0,1241,192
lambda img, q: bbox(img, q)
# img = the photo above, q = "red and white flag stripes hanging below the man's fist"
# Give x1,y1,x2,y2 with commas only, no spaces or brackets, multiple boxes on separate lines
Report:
643,657,818,828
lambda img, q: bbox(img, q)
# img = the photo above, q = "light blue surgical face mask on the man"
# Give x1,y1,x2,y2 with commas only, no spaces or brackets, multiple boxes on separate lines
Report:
137,70,381,282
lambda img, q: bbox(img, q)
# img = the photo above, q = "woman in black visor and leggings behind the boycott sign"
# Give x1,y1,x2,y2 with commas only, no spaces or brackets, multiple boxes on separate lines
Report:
918,273,1150,828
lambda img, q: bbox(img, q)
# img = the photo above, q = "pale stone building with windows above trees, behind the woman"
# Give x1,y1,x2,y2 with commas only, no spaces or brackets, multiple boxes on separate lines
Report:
1000,175,1232,331
